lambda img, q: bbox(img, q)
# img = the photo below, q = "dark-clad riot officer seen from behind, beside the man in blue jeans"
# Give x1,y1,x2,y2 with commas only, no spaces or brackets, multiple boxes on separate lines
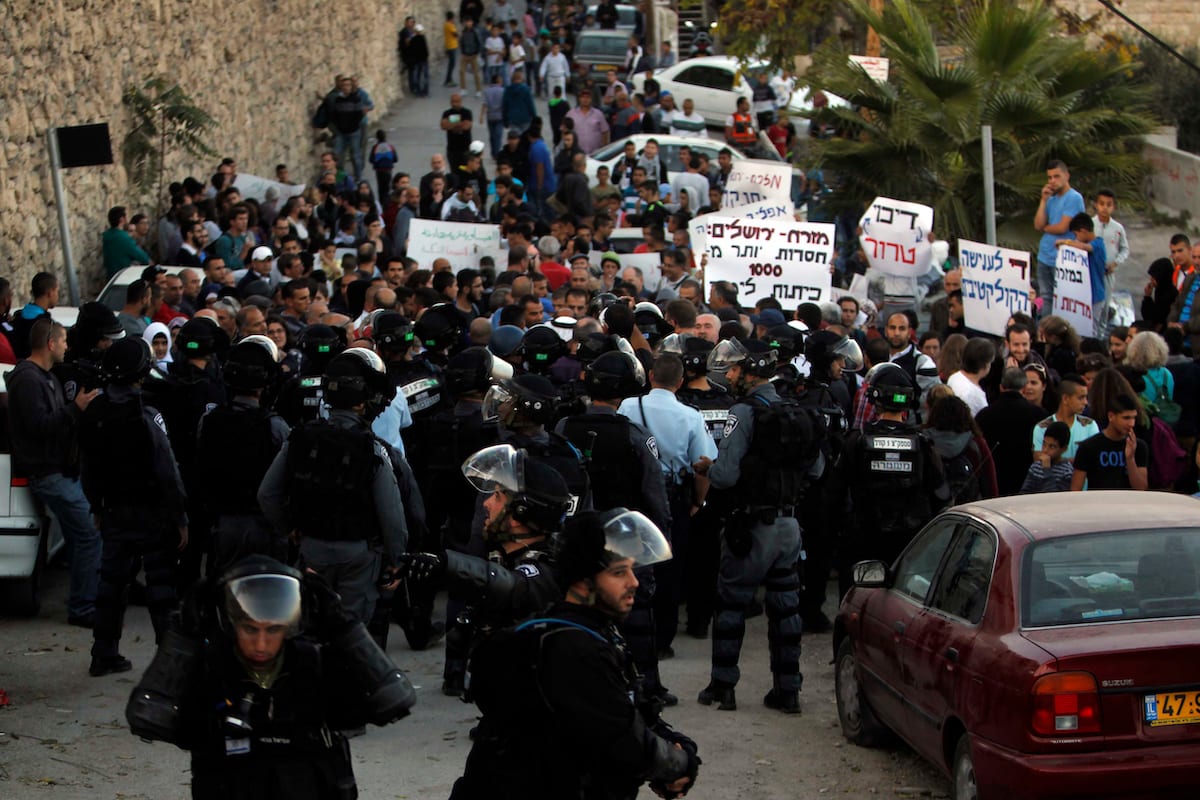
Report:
79,338,187,676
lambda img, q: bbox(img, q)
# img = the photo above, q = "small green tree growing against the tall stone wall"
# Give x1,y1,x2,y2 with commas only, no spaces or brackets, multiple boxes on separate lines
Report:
121,78,217,211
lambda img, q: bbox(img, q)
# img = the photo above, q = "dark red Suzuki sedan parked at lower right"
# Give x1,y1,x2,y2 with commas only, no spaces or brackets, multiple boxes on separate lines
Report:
833,492,1200,800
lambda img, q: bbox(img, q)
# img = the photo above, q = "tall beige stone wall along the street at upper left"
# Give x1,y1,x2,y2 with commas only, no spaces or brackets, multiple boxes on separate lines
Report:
0,0,422,302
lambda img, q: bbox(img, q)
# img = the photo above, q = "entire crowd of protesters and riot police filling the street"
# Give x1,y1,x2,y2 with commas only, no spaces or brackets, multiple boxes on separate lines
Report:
0,6,1200,798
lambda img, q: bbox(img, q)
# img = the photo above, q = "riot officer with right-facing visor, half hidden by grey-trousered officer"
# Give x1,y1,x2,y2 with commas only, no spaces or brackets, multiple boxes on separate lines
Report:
794,331,863,633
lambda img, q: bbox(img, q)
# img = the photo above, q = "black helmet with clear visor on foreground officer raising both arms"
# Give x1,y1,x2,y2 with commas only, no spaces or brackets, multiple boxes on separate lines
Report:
217,555,304,637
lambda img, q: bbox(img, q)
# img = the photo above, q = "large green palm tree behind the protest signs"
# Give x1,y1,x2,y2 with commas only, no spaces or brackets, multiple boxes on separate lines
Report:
808,0,1156,240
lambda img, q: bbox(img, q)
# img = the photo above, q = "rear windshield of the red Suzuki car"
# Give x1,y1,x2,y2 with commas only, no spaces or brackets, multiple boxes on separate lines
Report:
1021,528,1200,627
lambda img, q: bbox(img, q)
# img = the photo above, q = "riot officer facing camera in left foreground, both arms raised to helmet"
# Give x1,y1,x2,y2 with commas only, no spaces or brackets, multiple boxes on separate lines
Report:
126,555,416,800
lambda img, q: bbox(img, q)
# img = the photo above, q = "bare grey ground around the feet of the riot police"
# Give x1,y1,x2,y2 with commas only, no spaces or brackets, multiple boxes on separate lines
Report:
0,567,949,800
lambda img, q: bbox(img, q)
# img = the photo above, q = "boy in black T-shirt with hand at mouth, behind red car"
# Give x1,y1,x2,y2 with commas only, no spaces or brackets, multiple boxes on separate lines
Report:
1070,393,1150,492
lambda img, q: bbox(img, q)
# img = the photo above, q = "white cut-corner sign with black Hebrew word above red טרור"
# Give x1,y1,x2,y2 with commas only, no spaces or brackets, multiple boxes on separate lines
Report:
858,197,934,278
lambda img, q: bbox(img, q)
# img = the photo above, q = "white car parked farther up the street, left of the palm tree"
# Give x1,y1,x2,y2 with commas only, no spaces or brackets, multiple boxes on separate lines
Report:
632,55,848,131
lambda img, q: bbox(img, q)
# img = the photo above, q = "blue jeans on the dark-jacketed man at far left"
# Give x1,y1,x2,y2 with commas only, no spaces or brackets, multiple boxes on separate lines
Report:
29,473,100,616
